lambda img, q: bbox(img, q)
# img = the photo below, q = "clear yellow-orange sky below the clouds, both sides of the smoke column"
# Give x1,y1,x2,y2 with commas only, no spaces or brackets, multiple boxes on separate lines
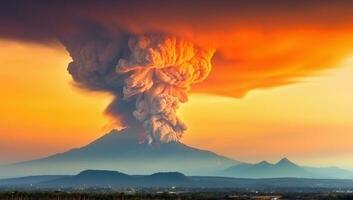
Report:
0,40,353,169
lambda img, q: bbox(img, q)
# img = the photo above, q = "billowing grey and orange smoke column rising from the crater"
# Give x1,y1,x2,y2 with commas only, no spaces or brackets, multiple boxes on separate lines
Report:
63,34,214,143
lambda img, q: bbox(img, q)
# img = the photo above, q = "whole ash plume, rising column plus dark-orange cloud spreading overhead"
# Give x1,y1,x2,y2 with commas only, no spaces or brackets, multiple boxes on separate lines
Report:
0,0,353,141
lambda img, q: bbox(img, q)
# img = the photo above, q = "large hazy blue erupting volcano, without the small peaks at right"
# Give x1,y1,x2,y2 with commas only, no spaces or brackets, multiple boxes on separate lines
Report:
0,129,239,177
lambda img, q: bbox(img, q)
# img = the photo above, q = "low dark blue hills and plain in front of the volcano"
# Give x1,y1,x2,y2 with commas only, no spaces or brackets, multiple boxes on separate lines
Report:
0,170,353,191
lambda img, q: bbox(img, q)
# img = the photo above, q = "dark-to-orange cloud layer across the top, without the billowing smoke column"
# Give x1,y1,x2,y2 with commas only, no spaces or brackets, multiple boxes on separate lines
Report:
0,0,353,97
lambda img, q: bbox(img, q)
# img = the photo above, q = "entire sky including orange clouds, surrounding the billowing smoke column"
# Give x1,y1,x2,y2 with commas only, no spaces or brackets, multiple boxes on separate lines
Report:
0,1,353,169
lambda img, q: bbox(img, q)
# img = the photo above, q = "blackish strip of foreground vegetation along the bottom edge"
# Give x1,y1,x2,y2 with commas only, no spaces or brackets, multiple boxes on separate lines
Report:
0,191,353,200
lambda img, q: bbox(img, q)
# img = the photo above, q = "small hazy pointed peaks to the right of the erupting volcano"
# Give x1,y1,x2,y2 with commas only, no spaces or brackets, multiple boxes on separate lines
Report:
220,158,353,179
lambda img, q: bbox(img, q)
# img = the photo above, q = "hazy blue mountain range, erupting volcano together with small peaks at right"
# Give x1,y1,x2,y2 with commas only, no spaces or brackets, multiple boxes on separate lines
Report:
0,129,353,179
